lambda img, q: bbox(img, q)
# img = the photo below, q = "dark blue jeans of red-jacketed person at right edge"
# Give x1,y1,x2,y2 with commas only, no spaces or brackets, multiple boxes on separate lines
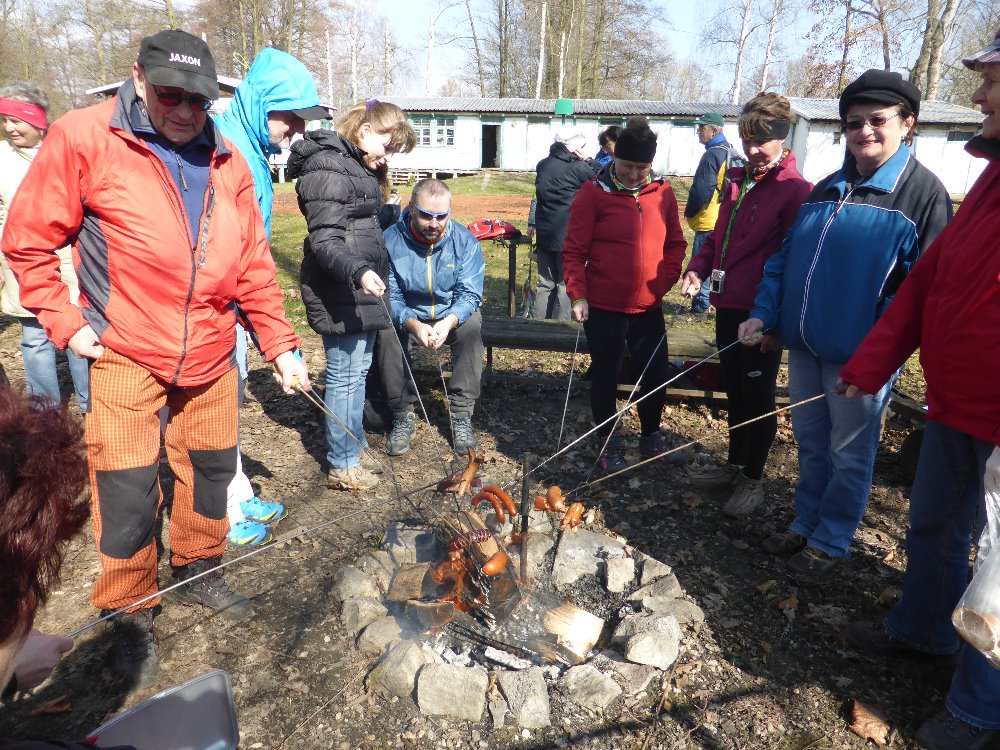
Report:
885,422,1000,729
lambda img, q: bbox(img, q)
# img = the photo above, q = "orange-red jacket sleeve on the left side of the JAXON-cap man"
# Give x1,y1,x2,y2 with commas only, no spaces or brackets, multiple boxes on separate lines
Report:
2,122,89,349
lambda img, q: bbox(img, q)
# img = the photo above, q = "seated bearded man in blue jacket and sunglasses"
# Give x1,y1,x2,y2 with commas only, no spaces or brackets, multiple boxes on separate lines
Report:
379,179,486,456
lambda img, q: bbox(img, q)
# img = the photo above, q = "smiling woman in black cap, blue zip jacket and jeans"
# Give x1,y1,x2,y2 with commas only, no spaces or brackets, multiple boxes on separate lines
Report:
739,70,951,574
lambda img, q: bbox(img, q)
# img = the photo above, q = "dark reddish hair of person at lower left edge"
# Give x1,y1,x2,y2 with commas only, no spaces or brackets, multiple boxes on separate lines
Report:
0,385,90,643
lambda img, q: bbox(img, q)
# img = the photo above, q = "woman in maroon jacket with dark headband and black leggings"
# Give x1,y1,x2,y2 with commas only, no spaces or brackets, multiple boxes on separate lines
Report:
681,92,810,518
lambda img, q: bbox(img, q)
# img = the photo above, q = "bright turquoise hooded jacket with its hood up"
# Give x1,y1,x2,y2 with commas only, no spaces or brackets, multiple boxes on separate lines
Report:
215,47,320,237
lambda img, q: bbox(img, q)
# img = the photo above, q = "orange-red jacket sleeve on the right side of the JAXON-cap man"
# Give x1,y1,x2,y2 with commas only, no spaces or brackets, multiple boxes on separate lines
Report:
236,165,300,362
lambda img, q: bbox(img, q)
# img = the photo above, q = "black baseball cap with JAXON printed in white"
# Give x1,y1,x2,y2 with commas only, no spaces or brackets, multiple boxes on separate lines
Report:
136,29,219,99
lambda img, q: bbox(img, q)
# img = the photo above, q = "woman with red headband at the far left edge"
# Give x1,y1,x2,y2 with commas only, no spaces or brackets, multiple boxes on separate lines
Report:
0,83,90,413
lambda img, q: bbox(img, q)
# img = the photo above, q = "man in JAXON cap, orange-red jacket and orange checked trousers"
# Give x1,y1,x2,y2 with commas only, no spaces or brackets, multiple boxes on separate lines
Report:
2,30,309,684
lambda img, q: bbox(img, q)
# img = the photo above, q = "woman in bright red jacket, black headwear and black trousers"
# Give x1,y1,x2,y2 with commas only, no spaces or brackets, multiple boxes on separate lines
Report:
563,117,687,474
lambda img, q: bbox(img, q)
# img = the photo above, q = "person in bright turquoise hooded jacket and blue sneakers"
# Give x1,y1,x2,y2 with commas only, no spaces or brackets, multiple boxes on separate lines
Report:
215,47,330,546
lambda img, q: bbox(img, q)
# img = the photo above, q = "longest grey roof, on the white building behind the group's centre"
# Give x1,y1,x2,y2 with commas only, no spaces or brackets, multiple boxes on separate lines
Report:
383,96,740,119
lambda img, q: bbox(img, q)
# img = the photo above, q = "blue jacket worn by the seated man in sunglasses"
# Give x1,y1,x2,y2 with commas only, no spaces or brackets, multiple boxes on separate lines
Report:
385,209,486,328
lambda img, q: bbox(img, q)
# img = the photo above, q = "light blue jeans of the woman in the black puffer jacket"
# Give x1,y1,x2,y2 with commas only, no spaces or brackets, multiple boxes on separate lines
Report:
323,331,376,469
